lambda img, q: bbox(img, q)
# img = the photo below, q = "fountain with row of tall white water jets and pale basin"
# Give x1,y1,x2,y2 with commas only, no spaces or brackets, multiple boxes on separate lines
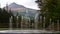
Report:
0,9,55,33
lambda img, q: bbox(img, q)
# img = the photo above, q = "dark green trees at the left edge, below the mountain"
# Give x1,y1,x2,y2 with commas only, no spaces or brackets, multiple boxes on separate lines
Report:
0,8,12,23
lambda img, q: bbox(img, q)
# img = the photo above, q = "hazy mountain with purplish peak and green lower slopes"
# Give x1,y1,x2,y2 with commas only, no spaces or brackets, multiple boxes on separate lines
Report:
5,2,37,16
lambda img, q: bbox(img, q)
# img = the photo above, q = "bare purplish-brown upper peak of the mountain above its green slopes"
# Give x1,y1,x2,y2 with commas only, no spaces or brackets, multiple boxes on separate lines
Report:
4,2,25,11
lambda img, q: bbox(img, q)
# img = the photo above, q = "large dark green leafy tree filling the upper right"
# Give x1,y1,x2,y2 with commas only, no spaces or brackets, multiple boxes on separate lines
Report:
36,0,60,26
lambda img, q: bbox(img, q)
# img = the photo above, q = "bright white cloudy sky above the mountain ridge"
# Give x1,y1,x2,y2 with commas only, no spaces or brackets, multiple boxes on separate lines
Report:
0,0,39,10
